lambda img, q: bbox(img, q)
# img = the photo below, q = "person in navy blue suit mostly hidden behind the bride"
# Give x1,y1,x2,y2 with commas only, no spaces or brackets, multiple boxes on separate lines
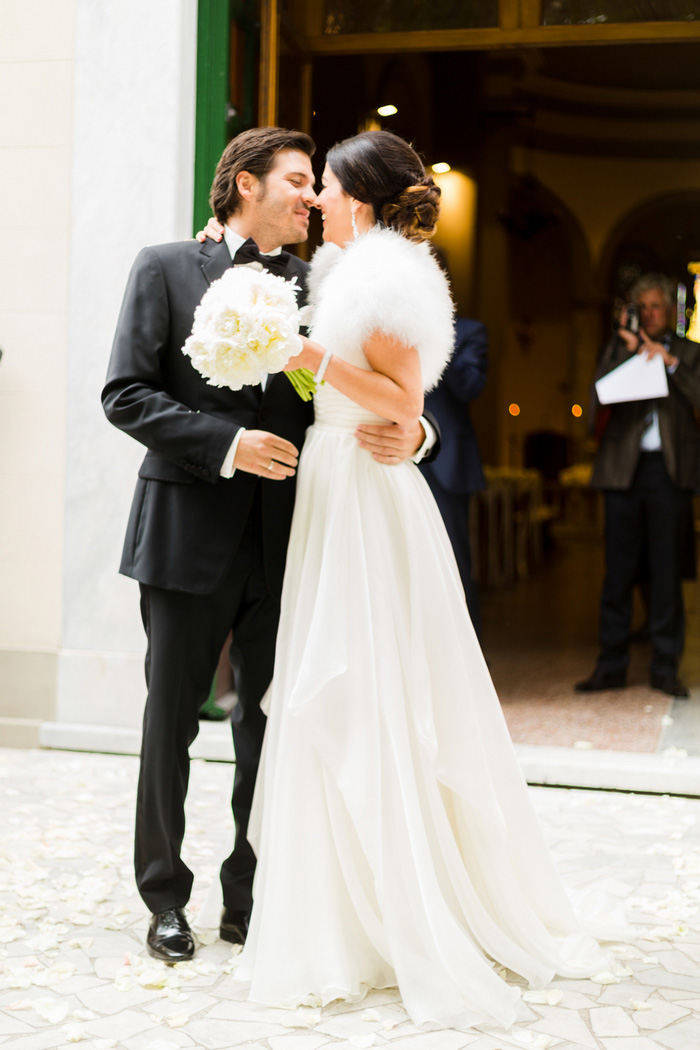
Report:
421,317,488,636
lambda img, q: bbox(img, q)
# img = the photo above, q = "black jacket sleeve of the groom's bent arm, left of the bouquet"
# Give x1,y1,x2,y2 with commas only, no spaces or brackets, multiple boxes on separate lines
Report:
102,248,239,482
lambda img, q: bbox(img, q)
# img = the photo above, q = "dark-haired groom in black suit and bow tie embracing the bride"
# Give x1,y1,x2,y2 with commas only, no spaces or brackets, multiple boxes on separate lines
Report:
102,127,438,963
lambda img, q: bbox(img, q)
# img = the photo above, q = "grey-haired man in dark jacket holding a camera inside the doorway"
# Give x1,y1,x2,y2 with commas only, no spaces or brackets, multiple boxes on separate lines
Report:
575,274,700,697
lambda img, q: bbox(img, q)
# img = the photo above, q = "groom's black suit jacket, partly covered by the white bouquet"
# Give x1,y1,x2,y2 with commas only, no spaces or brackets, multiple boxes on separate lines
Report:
102,239,313,594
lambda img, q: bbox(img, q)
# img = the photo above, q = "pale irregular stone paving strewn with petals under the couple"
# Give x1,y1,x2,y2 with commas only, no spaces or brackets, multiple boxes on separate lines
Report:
0,750,700,1050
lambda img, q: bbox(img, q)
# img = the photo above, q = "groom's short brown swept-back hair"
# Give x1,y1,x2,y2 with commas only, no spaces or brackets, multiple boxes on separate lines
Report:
209,127,316,223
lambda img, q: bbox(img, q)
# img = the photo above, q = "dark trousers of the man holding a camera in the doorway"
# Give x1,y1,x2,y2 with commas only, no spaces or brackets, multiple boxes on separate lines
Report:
598,452,691,674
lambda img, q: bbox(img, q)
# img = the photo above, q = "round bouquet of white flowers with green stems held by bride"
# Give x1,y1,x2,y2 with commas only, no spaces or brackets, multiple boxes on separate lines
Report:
183,266,316,401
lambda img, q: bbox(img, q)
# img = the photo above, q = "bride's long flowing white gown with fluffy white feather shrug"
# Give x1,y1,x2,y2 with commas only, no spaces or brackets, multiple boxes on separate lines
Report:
236,233,607,1027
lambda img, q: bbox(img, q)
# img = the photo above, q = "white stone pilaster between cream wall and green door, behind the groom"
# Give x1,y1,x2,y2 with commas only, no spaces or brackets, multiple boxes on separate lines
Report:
51,0,196,748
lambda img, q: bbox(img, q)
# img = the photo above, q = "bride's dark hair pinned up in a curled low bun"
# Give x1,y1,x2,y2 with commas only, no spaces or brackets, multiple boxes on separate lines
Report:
326,131,440,240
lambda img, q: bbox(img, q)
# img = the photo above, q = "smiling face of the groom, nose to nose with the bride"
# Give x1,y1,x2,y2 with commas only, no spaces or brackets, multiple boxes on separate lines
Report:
249,149,316,251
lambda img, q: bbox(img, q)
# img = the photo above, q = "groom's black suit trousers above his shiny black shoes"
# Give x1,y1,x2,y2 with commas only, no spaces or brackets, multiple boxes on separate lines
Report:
134,491,279,911
